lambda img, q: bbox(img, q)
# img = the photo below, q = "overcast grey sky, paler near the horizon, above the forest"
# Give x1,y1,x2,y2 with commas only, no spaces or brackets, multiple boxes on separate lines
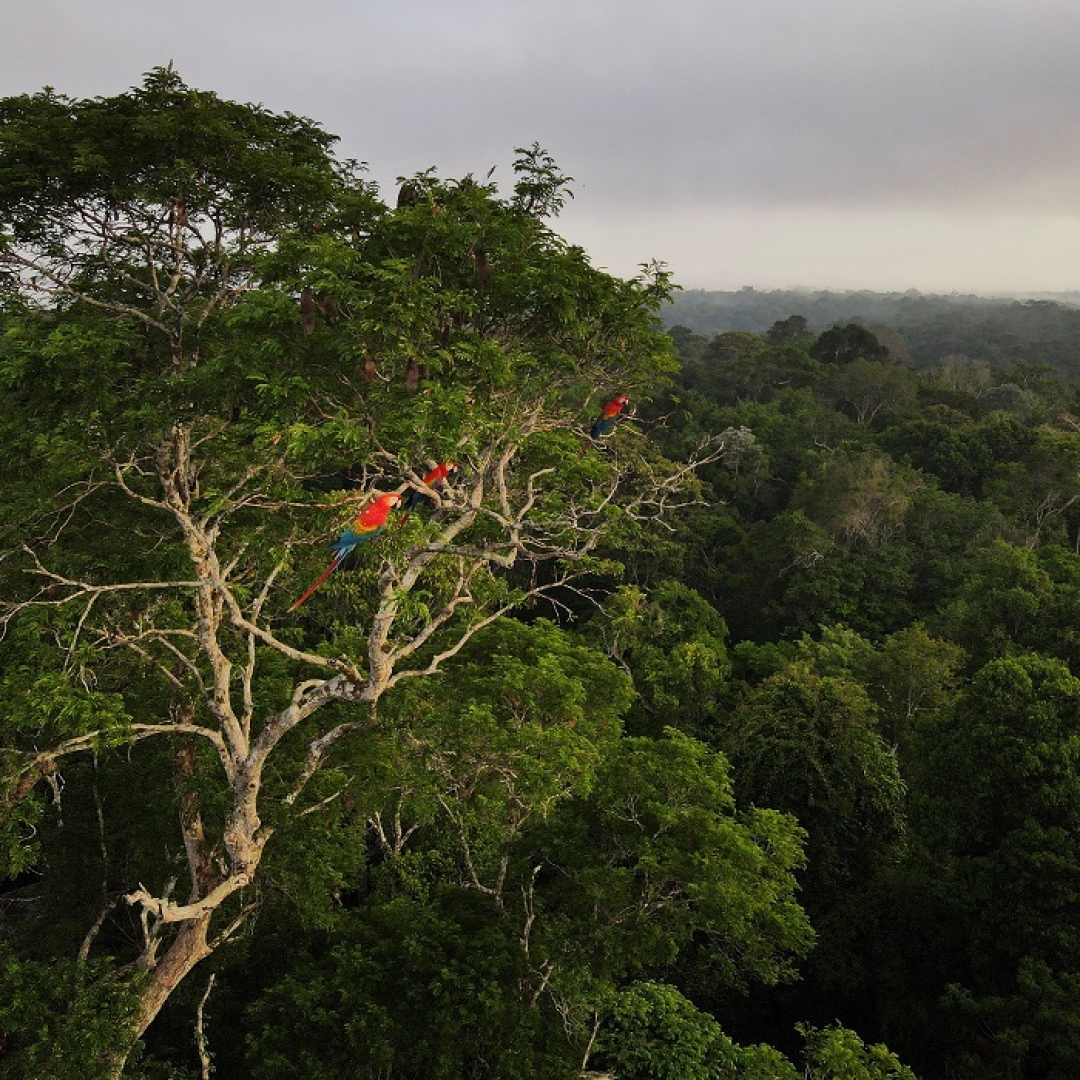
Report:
0,0,1080,294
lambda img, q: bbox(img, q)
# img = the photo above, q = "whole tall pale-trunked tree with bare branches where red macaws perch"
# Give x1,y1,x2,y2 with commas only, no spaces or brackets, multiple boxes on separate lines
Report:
0,69,720,1075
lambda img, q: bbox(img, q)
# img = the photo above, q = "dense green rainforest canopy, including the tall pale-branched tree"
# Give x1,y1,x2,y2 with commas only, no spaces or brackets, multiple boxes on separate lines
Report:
0,69,1080,1080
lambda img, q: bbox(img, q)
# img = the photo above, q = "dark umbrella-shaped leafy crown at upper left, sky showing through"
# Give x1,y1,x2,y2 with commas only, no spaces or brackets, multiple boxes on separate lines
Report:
0,67,347,370
